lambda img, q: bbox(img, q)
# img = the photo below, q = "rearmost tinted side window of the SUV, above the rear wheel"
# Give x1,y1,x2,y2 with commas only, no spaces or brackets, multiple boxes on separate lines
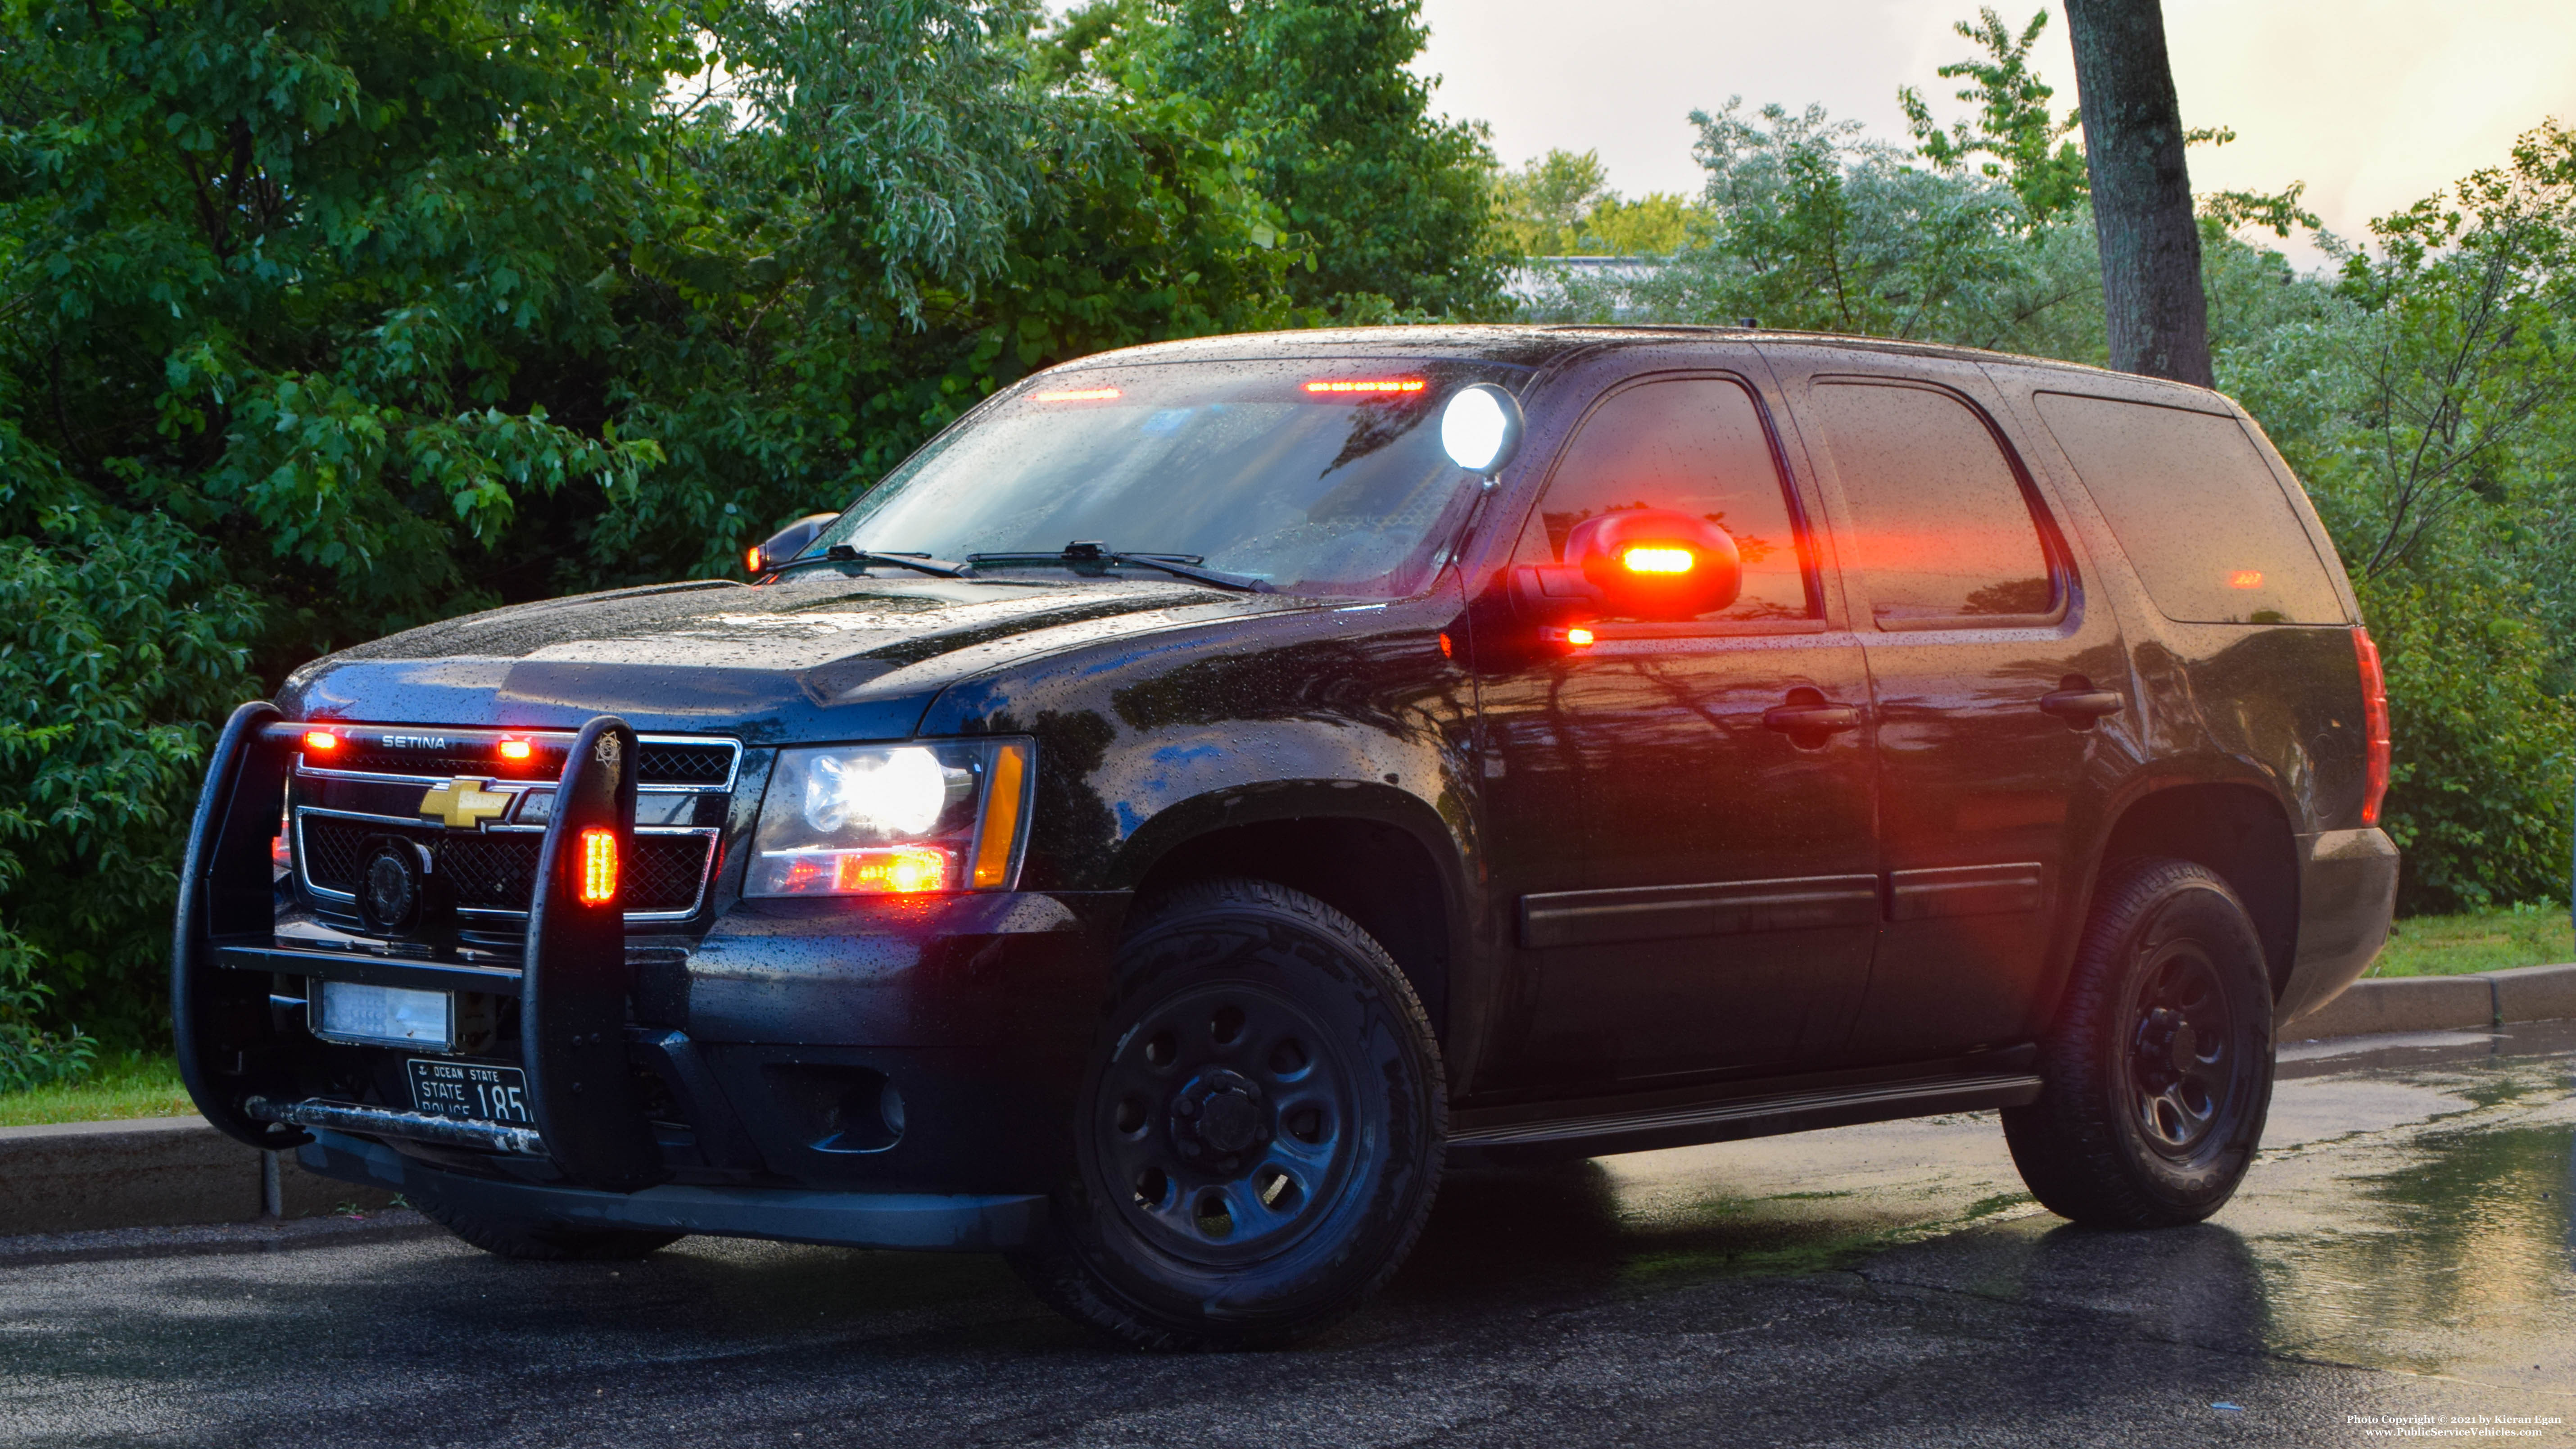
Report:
2037,392,2347,624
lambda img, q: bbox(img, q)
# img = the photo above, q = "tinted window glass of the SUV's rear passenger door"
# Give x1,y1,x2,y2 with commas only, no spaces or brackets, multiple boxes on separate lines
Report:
1816,381,2055,621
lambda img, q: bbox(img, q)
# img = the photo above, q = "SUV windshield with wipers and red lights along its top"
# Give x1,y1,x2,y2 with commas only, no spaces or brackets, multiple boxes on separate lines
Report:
806,358,1520,598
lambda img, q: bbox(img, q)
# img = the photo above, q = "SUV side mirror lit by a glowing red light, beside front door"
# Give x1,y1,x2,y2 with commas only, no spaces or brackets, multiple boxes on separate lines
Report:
1512,508,1744,624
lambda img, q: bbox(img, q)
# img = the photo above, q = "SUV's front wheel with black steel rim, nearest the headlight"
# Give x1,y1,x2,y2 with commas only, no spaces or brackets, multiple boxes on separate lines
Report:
1012,879,1448,1351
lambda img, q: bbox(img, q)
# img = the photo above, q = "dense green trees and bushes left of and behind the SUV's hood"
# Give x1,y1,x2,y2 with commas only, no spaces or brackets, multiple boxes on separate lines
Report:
0,0,1360,1039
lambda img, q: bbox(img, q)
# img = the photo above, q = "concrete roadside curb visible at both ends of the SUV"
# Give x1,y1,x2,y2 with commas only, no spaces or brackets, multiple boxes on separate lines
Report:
0,964,2576,1237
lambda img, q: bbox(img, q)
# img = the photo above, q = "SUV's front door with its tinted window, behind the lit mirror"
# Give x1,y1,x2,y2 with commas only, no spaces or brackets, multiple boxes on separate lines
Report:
1476,374,1878,1091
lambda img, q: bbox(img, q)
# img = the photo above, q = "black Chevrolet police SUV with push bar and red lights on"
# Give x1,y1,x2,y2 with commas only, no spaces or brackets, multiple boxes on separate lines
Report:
172,327,2396,1346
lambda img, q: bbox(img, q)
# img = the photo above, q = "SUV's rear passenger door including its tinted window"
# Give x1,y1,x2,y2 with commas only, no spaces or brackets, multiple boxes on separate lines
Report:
1796,348,2133,1046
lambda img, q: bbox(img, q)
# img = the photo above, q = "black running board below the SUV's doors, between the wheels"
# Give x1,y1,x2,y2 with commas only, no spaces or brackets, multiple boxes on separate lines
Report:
1450,1073,2040,1160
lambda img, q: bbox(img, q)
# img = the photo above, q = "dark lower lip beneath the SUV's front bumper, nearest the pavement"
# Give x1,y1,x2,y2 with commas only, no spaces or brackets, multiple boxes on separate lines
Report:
296,1127,1046,1253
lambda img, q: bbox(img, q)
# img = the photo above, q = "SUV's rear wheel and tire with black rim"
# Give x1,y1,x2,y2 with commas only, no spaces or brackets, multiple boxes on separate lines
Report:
2004,859,2272,1227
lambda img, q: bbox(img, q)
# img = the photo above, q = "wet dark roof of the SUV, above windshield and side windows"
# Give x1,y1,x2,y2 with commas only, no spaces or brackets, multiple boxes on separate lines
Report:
1064,322,2213,412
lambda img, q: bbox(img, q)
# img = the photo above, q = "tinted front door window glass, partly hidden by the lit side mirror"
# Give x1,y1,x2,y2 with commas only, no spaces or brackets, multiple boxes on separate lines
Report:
1520,376,1816,619
